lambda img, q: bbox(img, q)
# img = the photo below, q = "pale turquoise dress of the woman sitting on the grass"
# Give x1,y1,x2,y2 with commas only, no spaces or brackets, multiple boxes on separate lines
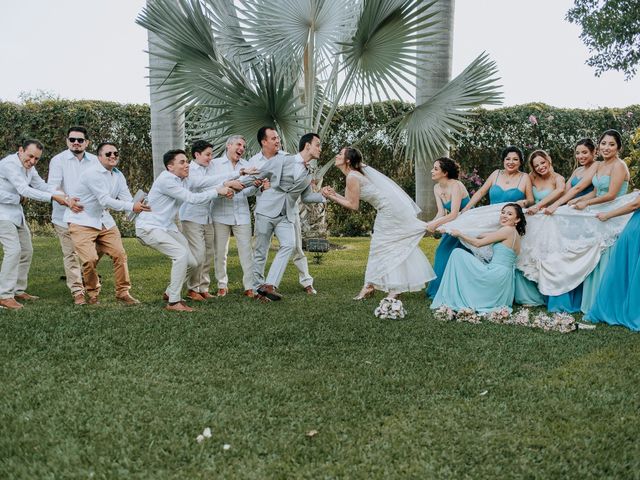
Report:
431,238,517,313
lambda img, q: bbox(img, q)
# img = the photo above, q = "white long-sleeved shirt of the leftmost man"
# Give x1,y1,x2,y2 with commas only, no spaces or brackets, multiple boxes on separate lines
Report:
0,153,56,227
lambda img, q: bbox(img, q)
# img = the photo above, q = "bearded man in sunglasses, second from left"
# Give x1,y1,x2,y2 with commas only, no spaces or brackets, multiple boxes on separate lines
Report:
47,125,99,305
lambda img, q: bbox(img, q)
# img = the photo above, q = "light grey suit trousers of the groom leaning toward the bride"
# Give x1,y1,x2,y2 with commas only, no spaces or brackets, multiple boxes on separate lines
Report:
253,214,296,290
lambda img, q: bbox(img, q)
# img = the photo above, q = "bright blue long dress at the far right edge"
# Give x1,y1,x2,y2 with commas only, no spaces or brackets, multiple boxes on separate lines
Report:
585,210,640,332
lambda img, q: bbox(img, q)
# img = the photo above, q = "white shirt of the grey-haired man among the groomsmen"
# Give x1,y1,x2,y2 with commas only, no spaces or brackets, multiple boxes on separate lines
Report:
211,155,256,225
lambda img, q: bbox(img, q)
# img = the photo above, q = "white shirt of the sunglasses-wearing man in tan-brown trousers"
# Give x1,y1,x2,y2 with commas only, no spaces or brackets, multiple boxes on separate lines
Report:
64,163,133,230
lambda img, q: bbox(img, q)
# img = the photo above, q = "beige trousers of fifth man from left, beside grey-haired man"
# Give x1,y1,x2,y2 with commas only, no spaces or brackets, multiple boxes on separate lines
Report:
180,220,215,293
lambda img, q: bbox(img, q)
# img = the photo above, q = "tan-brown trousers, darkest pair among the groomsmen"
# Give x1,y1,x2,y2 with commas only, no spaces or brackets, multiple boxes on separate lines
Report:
69,223,131,298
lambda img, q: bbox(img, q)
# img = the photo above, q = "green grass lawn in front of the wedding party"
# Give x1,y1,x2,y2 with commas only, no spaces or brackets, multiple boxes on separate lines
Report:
0,238,640,479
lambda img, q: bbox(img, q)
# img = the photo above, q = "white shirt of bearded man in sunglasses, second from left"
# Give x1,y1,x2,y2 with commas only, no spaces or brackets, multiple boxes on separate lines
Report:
47,150,100,228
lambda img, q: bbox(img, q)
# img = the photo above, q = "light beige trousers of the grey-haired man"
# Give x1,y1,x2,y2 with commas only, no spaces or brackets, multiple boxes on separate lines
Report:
213,222,253,290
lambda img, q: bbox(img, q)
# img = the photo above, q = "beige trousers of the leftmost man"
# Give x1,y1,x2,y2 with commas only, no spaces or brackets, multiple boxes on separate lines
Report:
0,220,33,299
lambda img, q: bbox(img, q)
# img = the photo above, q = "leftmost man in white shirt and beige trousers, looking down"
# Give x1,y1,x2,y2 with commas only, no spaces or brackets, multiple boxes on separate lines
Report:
0,140,80,310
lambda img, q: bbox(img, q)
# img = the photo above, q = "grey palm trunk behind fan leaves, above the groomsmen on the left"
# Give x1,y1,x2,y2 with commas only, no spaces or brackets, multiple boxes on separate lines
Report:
147,0,184,178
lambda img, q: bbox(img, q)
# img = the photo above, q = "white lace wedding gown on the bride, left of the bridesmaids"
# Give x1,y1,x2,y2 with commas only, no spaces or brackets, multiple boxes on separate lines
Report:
349,171,436,294
